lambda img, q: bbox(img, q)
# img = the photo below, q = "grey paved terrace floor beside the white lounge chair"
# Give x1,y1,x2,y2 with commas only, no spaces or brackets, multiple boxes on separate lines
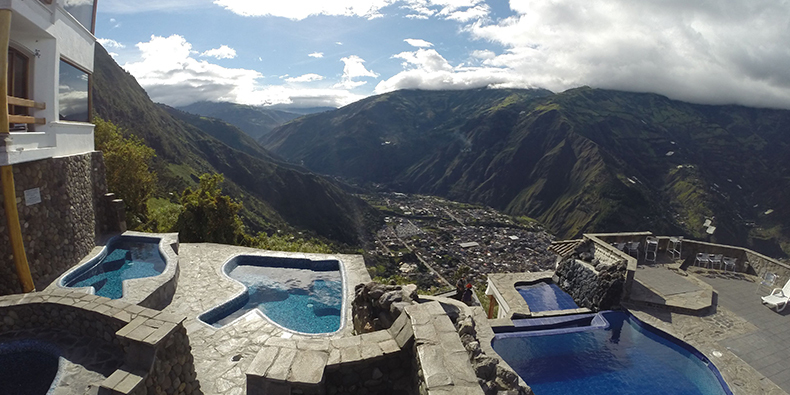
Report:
699,275,790,393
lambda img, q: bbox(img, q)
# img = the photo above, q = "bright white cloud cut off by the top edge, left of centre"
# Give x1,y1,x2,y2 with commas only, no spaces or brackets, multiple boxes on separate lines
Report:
214,0,398,20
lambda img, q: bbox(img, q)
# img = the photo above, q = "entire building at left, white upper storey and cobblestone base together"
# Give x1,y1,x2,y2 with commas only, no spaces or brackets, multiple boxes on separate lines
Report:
0,0,114,295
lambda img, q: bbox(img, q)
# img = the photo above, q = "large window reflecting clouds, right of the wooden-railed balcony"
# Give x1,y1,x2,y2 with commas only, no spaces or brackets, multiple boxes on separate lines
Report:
58,60,90,122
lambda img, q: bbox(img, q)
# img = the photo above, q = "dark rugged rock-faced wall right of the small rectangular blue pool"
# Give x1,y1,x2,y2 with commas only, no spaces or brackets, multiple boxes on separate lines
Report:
555,241,627,311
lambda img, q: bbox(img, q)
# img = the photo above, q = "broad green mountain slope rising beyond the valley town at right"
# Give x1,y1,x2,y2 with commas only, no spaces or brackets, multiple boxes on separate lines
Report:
262,88,790,255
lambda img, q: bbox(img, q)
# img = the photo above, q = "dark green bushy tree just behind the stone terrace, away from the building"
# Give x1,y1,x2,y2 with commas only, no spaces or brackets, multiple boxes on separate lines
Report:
176,174,244,244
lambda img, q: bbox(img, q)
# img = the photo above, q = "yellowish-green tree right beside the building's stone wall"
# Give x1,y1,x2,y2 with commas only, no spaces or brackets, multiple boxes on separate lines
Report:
93,117,157,229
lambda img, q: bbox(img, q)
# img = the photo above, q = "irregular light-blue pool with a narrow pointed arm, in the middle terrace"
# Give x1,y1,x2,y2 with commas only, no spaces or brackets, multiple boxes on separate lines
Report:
199,255,343,334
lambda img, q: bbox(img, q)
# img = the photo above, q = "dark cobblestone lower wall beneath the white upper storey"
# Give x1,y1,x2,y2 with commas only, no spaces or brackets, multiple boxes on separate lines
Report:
0,152,117,295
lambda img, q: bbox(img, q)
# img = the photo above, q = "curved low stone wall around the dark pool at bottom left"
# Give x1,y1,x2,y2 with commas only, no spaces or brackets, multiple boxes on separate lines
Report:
0,290,202,395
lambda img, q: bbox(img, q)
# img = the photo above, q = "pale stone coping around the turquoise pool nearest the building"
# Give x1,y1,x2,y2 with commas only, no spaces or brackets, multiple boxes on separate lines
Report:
45,231,179,310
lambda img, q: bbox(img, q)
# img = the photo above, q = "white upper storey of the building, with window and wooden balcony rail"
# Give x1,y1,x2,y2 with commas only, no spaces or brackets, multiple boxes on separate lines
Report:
0,0,96,166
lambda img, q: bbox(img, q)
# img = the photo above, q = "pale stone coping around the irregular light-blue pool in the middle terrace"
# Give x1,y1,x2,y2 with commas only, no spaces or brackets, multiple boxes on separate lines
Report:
195,250,351,338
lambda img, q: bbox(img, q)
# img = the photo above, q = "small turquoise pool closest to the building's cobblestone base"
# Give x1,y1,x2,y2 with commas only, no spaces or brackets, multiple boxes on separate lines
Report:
60,236,167,299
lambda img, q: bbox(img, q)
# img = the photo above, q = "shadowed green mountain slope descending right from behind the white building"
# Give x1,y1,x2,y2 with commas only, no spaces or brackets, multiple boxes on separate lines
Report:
93,45,371,244
